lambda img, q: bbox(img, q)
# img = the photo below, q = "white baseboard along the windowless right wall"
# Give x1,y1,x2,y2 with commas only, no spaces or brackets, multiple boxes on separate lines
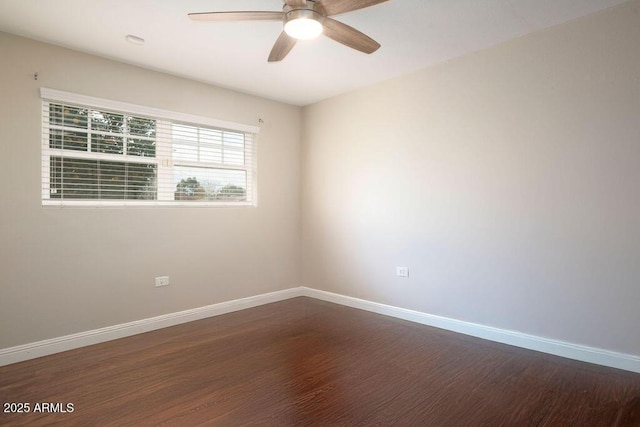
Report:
302,287,640,373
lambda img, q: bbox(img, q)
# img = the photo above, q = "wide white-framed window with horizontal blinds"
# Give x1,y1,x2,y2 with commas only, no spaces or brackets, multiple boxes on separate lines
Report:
42,89,258,206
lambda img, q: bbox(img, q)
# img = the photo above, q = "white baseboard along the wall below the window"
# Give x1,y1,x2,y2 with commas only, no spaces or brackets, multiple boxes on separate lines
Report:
0,288,301,366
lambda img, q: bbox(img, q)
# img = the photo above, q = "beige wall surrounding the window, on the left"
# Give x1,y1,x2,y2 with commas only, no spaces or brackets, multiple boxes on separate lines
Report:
0,33,301,348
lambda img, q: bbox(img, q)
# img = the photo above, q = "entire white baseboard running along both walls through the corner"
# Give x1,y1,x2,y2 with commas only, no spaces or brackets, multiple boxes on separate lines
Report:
0,287,640,373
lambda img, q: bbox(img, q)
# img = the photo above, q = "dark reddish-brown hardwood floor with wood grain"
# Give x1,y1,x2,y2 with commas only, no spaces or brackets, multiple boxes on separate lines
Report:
0,298,640,426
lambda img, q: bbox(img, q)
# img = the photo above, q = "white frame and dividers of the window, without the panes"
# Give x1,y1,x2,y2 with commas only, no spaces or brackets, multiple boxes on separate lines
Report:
40,88,260,207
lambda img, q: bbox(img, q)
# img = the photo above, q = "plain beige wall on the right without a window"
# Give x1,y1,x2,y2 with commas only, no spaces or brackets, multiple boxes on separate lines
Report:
302,1,640,355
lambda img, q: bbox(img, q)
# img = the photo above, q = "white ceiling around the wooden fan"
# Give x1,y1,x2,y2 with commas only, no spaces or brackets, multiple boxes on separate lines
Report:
0,0,625,105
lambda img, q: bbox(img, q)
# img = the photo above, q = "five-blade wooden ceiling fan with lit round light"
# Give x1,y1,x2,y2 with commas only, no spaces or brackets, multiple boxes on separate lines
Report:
189,0,388,62
